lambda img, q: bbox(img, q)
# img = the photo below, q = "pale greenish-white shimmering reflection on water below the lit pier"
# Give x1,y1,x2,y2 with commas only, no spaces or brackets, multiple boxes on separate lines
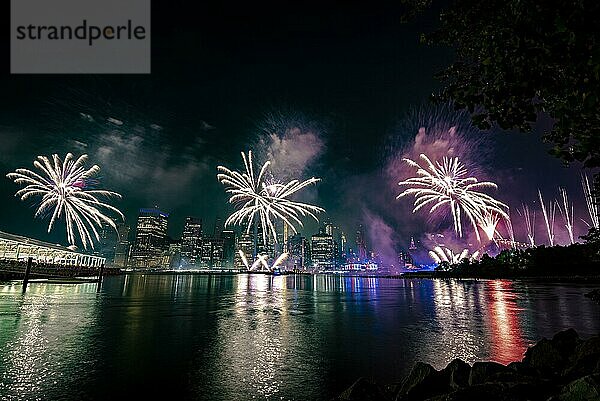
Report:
0,284,101,400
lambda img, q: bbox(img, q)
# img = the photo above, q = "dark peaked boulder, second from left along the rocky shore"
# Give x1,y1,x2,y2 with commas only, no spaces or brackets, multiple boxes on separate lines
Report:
396,362,452,400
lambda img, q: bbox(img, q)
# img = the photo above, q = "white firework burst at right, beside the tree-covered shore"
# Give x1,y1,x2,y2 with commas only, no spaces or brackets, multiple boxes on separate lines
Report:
396,154,509,241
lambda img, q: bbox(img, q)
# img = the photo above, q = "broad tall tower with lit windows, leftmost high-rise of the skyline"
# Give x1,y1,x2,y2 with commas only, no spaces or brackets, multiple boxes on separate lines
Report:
130,208,169,268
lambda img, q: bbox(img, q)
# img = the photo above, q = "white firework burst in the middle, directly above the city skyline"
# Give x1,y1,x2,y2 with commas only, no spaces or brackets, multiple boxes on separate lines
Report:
217,151,324,243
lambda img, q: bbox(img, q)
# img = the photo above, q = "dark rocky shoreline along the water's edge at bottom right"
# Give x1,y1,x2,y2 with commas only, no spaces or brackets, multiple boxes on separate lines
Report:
334,328,600,401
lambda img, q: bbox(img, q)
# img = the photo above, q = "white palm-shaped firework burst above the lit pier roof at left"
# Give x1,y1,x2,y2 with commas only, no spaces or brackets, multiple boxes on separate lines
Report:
6,153,125,249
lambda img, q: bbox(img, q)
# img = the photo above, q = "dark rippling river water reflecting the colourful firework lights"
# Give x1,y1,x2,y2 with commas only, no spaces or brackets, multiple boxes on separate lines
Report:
0,274,600,400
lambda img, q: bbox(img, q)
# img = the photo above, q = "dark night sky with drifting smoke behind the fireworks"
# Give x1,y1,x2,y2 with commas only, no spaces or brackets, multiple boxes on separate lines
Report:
0,0,584,256
